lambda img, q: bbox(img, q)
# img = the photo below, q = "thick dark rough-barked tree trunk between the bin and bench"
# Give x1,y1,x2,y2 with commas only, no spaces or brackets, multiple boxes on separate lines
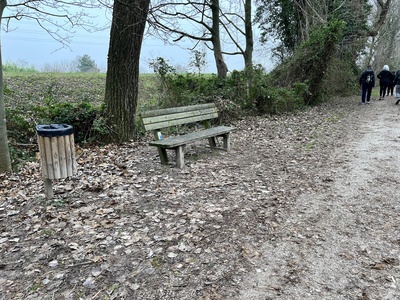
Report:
105,0,150,142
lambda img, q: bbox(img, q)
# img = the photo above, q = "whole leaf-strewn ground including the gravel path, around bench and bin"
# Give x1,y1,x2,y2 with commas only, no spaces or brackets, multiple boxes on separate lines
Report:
0,97,400,300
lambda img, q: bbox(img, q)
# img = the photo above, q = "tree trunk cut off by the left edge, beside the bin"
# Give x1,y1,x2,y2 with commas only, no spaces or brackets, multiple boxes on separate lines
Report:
0,0,11,173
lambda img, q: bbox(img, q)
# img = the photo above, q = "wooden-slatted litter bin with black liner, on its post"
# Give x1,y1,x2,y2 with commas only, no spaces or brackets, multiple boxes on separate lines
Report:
36,124,77,199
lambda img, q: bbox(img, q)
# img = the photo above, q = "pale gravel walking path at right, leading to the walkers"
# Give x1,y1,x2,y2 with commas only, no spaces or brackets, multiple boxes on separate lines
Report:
238,100,400,300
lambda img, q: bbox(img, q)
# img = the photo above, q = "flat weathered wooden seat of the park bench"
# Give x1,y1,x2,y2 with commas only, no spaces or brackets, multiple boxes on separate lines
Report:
149,126,235,149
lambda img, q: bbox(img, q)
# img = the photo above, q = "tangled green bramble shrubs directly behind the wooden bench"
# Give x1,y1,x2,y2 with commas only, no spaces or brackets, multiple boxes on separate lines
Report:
142,61,309,121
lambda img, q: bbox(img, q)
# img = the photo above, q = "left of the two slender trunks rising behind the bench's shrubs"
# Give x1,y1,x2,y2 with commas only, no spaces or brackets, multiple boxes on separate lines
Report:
211,0,228,78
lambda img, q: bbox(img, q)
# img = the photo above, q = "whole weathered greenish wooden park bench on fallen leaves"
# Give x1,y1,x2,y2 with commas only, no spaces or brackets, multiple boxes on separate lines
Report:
140,103,235,168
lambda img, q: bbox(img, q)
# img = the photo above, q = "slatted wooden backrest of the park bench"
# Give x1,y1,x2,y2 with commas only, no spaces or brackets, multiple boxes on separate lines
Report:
140,103,218,130
